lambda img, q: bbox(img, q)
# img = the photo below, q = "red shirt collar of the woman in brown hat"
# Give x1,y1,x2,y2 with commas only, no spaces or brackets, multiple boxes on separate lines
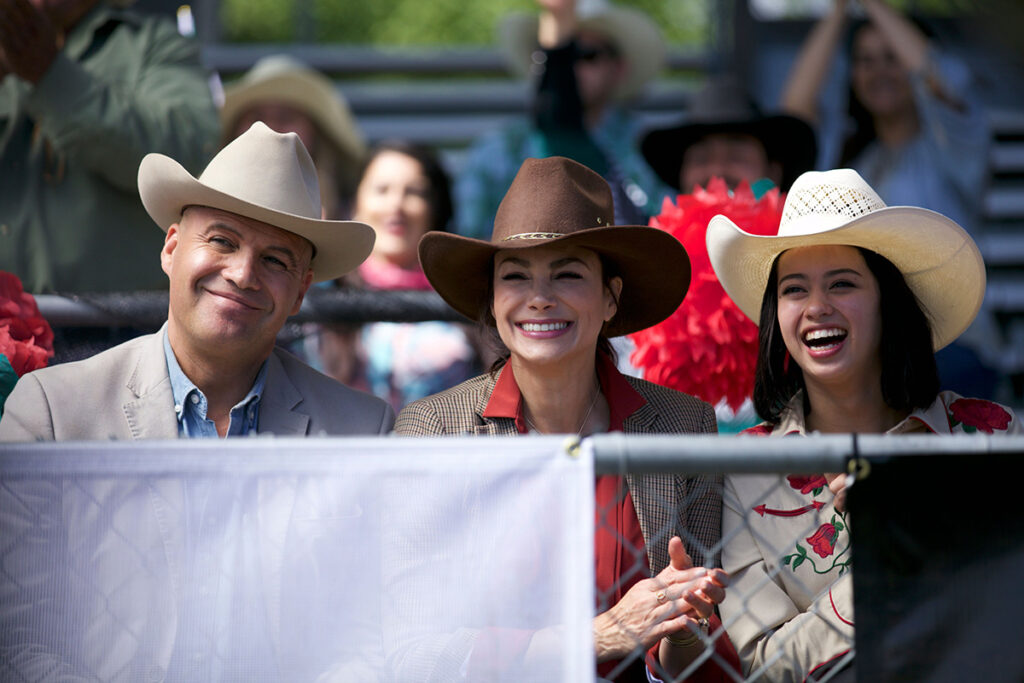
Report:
482,353,647,434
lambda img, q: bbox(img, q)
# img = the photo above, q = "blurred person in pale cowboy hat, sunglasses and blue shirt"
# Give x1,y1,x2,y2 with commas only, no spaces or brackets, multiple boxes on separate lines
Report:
455,0,668,239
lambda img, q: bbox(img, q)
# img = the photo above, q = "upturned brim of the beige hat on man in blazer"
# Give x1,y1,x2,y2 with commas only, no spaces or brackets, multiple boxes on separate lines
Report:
138,154,375,282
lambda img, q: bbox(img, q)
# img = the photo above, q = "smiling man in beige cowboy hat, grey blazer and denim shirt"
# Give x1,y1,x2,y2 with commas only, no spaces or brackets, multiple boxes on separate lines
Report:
0,123,394,441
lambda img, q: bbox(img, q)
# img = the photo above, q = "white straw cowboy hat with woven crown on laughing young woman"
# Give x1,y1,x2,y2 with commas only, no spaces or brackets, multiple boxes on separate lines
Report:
707,169,985,350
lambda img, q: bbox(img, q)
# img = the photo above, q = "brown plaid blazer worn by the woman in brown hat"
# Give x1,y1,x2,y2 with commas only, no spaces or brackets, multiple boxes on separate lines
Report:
395,374,722,573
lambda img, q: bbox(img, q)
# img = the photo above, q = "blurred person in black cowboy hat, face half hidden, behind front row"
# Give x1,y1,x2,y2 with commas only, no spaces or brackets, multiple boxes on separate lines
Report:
641,76,817,193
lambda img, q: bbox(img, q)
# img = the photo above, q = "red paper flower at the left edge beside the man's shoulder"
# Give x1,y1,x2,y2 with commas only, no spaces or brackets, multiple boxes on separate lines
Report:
0,271,53,377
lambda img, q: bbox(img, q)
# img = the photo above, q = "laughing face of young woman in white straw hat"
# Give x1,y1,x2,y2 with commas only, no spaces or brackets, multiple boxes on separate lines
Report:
778,245,882,388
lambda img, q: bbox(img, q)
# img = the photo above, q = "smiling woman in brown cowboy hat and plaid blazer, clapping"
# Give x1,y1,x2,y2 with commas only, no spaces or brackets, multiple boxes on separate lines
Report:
395,157,736,681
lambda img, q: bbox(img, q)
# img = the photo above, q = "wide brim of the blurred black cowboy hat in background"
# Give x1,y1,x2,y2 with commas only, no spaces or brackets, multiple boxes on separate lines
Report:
640,115,818,193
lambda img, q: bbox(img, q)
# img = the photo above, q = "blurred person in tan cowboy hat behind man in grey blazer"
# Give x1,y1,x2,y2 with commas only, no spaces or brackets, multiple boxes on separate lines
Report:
220,54,367,218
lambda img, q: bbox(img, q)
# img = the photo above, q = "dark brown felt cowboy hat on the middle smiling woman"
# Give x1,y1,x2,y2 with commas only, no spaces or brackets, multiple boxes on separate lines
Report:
420,157,690,337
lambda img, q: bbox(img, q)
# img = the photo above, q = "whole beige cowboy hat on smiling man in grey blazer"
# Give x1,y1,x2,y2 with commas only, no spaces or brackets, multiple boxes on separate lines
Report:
138,121,374,282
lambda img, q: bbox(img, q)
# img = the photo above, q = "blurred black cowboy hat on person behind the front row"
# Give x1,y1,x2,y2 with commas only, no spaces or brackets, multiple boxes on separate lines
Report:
640,76,818,193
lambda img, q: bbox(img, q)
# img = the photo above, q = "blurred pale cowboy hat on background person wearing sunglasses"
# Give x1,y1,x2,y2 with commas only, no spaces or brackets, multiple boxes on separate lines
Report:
498,0,666,99
